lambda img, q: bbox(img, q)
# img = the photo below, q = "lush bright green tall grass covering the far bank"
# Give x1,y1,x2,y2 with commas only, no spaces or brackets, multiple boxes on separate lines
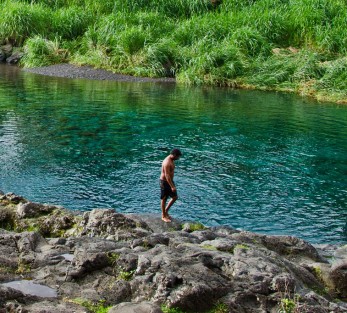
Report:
0,0,347,102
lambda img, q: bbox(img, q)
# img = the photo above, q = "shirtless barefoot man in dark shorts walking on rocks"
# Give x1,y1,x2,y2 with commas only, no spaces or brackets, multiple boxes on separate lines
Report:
160,149,182,223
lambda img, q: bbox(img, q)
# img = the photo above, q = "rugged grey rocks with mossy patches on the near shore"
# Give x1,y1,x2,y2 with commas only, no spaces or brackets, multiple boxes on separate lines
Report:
0,192,347,313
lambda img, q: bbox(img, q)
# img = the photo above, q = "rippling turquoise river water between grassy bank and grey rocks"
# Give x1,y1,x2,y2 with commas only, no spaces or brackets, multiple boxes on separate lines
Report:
0,66,347,243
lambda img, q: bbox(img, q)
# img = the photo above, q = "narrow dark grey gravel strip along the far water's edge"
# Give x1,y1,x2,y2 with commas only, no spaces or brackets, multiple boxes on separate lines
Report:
23,64,176,83
